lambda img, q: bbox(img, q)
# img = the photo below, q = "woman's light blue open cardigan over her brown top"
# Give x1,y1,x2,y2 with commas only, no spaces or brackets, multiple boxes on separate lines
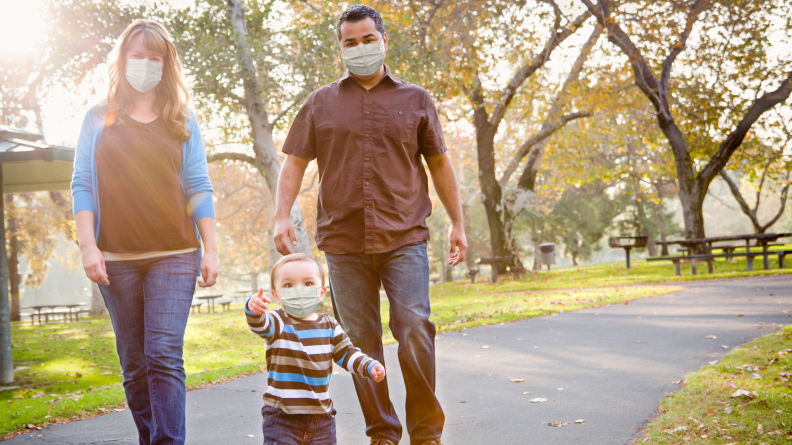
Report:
71,104,215,255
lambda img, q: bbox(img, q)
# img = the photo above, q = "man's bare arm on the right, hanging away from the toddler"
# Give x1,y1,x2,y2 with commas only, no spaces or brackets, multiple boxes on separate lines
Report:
424,153,467,266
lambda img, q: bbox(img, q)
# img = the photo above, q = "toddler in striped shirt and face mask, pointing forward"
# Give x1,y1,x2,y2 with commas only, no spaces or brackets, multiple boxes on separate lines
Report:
245,253,385,445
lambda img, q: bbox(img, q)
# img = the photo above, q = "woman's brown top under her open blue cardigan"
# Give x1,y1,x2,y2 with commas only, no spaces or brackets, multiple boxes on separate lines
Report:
96,118,200,253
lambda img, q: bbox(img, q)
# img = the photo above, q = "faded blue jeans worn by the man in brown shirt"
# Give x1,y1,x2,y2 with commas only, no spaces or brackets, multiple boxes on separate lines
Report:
326,241,445,442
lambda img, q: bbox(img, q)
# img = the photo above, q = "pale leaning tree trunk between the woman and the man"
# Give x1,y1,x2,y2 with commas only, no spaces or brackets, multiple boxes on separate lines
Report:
227,0,312,253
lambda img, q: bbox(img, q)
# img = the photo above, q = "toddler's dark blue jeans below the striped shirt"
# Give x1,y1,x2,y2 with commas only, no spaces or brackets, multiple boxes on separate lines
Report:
261,405,336,445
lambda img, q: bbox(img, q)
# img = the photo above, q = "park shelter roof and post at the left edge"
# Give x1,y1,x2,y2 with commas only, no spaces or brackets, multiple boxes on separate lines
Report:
0,125,74,384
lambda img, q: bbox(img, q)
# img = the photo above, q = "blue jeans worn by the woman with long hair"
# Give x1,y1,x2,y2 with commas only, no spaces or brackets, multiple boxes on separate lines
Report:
99,252,198,445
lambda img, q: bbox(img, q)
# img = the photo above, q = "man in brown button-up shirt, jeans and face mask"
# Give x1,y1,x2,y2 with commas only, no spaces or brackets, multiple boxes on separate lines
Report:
275,5,467,445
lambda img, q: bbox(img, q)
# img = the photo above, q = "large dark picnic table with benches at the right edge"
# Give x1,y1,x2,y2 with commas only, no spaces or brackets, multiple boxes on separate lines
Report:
647,233,792,275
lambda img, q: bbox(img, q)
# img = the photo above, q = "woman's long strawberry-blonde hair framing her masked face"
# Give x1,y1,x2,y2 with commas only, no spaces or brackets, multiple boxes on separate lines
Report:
102,19,192,141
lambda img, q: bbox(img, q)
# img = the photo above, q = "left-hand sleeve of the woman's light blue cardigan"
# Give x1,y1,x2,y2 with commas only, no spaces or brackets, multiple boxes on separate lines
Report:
71,107,104,215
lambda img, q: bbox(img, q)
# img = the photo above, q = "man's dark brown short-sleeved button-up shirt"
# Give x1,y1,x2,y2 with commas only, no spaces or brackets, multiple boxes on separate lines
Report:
283,66,446,254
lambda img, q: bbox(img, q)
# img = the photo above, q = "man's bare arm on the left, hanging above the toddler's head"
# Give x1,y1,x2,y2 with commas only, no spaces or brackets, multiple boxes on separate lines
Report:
275,155,311,255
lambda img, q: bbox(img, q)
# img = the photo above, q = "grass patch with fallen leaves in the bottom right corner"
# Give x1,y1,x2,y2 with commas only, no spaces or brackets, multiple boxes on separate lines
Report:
636,326,792,445
